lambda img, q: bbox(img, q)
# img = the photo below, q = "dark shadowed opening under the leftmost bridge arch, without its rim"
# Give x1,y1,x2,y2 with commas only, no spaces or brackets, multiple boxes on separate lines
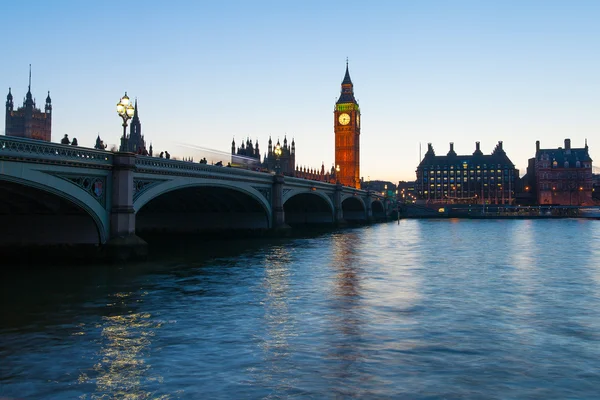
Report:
0,180,101,246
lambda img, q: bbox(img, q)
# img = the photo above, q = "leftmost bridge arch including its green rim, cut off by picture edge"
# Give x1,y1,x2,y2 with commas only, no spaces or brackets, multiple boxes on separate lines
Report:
0,177,109,245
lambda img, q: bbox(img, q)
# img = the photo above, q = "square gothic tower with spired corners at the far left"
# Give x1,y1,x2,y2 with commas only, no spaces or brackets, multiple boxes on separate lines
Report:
4,78,52,142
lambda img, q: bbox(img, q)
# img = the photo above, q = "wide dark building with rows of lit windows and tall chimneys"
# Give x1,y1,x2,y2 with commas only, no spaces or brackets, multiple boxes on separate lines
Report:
415,141,519,204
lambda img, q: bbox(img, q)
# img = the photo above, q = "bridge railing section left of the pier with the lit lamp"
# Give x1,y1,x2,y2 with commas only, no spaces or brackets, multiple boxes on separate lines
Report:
0,136,113,165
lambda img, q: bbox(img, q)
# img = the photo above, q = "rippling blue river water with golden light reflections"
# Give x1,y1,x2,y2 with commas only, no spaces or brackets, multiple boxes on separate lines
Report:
0,220,600,399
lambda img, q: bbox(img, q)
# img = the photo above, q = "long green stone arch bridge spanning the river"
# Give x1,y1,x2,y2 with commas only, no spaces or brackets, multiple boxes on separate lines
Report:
0,136,389,260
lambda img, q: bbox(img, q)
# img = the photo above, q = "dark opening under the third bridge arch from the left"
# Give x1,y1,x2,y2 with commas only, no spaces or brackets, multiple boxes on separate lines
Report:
283,193,333,226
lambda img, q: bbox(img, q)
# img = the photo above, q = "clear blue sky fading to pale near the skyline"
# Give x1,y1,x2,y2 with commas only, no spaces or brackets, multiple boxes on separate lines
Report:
0,0,600,181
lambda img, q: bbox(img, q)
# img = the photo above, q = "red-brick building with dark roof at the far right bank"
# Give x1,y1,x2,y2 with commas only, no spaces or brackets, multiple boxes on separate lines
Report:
527,139,593,206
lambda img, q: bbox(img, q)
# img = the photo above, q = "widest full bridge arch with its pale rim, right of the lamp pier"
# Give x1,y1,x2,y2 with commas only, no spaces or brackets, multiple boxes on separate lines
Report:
133,178,272,233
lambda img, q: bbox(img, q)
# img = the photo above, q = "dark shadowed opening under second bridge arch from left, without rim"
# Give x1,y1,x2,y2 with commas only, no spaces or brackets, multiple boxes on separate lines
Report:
136,186,269,237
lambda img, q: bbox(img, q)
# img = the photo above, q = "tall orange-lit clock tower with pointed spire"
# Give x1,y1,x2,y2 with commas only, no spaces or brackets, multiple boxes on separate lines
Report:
333,60,360,189
